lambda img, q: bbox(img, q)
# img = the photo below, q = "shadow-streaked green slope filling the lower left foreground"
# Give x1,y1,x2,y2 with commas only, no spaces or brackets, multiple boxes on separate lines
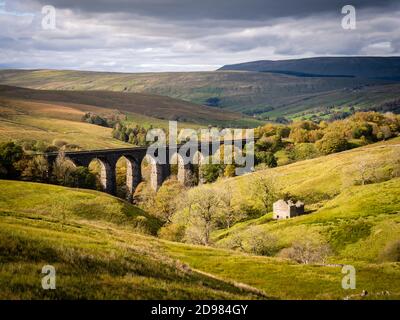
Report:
0,180,262,299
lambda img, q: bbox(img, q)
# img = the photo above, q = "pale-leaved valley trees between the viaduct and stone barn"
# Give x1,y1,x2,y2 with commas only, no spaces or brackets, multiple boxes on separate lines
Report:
141,178,281,245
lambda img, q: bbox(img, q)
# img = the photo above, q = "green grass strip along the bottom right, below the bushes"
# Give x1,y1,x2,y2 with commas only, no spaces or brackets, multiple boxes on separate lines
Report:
165,243,400,300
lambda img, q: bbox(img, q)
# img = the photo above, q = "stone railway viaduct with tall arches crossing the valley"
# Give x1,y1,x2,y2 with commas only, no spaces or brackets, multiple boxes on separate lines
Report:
45,140,249,200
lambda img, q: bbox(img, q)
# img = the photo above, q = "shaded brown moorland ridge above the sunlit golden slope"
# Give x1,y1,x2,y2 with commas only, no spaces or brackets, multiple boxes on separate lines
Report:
0,85,253,125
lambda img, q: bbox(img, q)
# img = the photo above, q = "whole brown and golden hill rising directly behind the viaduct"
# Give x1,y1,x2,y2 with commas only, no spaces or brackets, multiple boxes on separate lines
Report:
0,86,260,149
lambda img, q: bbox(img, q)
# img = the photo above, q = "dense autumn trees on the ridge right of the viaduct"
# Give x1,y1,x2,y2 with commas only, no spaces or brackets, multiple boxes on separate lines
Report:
255,111,400,167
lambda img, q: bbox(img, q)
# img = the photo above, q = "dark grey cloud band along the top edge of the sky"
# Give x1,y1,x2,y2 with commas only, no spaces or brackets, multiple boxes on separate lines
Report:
30,0,398,20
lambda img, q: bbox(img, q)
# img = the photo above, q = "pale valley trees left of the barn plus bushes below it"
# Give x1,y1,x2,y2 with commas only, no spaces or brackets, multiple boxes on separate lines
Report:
136,176,332,264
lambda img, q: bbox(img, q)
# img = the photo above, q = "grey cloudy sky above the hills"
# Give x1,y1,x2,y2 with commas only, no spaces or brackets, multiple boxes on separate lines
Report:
0,0,400,72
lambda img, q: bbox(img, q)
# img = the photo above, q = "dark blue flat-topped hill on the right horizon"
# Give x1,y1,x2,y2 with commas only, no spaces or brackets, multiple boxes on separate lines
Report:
219,57,400,81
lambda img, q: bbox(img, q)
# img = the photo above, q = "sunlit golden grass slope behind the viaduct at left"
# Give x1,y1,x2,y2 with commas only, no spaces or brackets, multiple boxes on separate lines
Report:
0,90,255,149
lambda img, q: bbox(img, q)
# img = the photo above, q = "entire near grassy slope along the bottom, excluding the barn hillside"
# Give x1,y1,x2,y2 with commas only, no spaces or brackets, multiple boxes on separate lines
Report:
0,181,400,299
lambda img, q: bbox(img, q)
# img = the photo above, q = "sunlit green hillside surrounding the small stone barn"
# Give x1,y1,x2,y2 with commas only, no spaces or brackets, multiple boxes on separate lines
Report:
187,138,400,263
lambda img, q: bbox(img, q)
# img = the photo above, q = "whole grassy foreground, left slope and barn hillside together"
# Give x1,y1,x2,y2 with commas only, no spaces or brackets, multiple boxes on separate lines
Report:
0,138,400,299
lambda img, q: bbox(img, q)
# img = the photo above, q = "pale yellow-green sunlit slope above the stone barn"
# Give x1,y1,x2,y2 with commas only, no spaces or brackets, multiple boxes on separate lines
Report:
208,137,400,209
